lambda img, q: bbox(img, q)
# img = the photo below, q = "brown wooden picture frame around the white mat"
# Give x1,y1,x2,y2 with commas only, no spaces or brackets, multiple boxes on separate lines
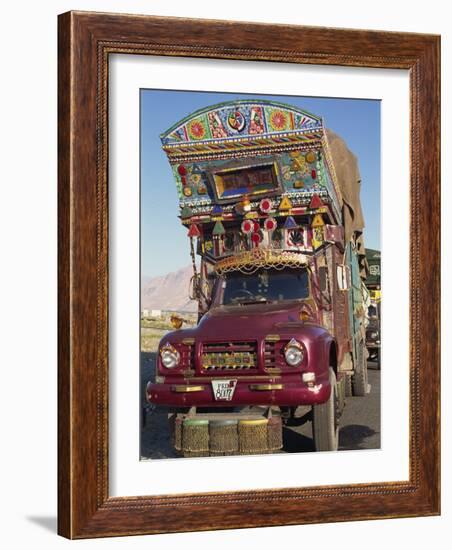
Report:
58,12,440,538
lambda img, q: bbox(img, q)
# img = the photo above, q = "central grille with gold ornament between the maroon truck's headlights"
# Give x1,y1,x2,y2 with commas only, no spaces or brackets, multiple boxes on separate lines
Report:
201,341,257,372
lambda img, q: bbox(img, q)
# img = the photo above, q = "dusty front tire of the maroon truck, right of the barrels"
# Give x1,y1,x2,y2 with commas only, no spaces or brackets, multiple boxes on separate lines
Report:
312,367,339,451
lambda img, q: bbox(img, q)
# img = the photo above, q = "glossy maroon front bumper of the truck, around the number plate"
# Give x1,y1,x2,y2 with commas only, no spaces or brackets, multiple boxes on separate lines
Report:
146,378,331,407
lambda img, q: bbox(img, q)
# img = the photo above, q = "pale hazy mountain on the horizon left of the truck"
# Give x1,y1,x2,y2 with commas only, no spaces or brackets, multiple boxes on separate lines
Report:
141,265,198,312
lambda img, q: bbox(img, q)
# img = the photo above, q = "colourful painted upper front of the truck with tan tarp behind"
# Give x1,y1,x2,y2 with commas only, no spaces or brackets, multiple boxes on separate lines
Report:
160,99,366,276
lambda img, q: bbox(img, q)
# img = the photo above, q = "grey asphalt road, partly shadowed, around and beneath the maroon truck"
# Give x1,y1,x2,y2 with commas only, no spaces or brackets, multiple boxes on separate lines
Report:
141,353,380,459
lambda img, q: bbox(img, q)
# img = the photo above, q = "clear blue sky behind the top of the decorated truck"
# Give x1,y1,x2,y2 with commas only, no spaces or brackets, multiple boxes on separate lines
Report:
141,90,380,277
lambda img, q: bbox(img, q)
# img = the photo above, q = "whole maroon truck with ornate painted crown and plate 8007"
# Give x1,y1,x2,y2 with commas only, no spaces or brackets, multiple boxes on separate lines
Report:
146,100,368,456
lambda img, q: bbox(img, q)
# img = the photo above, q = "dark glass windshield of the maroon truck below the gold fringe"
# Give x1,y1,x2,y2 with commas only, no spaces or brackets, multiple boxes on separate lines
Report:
222,268,309,305
